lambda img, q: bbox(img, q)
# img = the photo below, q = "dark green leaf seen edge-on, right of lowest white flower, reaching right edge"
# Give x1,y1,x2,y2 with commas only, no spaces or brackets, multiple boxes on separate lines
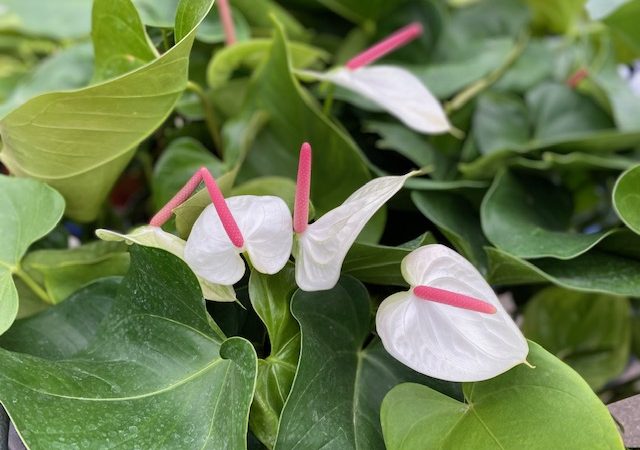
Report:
486,244,640,297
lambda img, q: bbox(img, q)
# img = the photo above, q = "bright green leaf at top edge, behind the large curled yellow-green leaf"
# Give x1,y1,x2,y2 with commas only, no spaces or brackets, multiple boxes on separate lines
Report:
91,0,158,81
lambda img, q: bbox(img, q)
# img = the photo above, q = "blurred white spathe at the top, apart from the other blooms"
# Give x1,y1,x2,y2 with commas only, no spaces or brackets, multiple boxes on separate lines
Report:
303,65,451,134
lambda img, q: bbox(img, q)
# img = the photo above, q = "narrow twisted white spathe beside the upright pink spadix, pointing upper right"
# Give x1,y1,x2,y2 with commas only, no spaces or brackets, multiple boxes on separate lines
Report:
294,171,420,291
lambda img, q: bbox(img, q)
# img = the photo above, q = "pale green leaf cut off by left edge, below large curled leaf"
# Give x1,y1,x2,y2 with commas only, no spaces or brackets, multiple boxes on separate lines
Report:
0,175,64,334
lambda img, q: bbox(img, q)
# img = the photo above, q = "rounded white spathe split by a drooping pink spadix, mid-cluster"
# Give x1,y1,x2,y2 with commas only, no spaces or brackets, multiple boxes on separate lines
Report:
184,195,293,285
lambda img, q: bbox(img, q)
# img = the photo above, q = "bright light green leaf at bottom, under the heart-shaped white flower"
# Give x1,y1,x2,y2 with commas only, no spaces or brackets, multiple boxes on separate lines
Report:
382,342,624,450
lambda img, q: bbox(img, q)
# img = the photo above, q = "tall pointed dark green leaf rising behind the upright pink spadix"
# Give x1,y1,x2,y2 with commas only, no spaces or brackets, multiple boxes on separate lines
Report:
240,21,384,240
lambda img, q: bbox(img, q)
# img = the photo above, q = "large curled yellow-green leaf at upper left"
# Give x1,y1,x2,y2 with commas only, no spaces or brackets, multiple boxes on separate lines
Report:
0,0,213,221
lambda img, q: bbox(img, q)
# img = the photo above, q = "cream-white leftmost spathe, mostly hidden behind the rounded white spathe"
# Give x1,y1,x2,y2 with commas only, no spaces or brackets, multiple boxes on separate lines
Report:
96,225,236,302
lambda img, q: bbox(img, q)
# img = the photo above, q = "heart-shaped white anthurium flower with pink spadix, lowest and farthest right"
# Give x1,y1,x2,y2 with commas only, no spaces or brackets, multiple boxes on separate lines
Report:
376,244,529,382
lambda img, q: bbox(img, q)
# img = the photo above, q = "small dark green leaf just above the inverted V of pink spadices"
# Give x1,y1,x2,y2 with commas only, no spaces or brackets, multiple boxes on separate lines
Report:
151,137,224,210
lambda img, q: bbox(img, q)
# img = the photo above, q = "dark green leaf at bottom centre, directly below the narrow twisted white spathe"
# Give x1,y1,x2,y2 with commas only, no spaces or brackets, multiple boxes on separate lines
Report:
276,277,457,450
